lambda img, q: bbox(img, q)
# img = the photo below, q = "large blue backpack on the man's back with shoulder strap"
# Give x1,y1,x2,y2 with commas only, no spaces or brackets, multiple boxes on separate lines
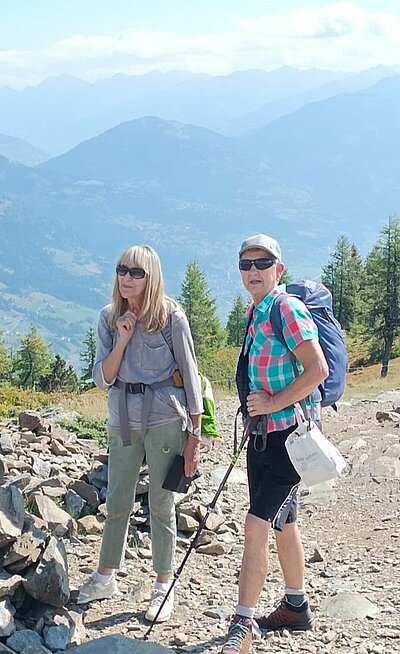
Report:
270,279,347,408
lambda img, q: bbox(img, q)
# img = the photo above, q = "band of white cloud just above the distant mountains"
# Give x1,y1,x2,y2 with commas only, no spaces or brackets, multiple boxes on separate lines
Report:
0,2,400,86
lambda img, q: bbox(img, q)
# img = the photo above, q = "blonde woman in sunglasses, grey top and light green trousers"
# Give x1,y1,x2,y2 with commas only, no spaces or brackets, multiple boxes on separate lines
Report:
78,245,203,622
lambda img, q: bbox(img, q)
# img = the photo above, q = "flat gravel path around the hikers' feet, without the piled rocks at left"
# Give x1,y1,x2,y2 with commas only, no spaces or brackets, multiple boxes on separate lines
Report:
67,394,400,654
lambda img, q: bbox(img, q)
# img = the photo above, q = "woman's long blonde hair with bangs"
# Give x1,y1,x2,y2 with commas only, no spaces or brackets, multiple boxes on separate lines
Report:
108,245,175,334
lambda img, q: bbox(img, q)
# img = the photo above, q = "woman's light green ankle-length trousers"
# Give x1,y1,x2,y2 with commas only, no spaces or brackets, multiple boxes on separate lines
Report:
99,420,186,574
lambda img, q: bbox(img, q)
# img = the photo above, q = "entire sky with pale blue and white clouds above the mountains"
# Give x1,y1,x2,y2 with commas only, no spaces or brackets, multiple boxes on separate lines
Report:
0,0,400,88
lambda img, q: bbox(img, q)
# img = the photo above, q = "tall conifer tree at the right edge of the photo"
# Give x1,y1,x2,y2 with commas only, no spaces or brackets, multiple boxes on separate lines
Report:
363,216,400,377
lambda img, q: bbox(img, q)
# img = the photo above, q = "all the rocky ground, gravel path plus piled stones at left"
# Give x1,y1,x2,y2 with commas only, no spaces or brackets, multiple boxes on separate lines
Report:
0,392,400,654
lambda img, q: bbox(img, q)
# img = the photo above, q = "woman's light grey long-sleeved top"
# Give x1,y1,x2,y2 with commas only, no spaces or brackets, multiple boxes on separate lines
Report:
93,305,203,430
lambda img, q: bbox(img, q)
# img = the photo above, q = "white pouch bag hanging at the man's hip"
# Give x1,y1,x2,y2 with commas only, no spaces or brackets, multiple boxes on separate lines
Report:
285,407,346,486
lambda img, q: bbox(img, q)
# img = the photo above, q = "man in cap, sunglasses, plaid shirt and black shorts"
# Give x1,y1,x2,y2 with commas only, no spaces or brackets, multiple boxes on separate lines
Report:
222,234,329,654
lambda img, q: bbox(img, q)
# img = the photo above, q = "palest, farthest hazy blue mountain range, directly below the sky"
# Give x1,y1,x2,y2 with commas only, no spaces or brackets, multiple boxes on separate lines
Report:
0,67,349,155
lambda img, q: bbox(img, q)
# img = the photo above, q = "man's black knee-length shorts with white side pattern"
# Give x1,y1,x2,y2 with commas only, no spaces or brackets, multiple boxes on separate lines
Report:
247,425,300,531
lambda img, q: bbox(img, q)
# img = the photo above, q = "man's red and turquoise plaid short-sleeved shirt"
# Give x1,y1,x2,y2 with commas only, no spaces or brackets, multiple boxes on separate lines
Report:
242,289,321,432
